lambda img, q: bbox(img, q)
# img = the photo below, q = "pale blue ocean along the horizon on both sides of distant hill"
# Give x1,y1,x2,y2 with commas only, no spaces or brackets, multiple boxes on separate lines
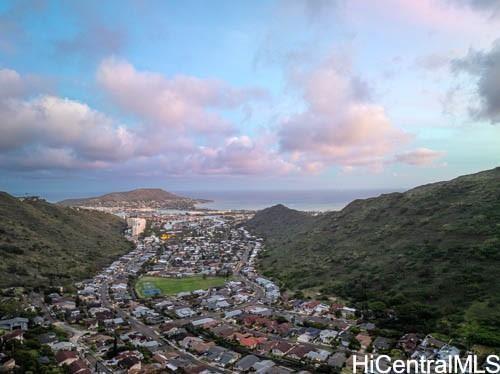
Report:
29,189,394,212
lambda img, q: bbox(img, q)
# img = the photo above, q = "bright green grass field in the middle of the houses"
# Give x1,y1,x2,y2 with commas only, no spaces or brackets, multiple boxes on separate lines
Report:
135,276,228,298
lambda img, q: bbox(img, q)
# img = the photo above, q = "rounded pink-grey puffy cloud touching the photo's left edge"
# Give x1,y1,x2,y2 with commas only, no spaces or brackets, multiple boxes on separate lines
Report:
0,96,135,160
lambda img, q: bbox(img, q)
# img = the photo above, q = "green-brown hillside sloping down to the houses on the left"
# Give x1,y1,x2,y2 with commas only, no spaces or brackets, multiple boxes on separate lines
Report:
0,192,131,287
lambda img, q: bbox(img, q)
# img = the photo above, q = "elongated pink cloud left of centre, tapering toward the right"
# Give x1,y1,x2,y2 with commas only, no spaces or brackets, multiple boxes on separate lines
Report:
97,58,265,133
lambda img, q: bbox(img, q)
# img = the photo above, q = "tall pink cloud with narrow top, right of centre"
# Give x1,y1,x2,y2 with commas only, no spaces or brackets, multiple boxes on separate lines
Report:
279,53,410,171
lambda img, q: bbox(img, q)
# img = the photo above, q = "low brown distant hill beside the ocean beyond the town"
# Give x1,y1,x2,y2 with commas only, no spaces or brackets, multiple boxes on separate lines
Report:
58,188,209,209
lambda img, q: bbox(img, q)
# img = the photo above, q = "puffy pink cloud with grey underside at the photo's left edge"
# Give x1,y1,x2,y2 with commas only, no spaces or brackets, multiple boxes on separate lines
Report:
0,91,136,168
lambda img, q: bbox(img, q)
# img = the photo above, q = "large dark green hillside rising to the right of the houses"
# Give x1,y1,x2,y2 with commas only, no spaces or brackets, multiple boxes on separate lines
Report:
247,168,500,346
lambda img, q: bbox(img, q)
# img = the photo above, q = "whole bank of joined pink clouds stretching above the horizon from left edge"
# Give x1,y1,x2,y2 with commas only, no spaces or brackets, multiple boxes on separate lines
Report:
0,57,442,176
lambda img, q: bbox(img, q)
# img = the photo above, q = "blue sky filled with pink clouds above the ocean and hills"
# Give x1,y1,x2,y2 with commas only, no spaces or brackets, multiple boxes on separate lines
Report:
0,0,500,195
